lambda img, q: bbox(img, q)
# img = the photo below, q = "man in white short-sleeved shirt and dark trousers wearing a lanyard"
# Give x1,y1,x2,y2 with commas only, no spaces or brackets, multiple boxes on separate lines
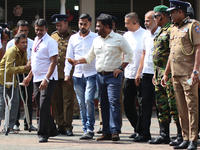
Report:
23,19,58,142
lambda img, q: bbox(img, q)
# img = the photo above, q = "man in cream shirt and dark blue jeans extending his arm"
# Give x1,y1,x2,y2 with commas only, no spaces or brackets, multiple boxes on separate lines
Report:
67,14,133,141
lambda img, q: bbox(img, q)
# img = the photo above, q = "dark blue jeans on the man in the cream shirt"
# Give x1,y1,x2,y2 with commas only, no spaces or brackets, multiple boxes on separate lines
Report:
96,73,122,134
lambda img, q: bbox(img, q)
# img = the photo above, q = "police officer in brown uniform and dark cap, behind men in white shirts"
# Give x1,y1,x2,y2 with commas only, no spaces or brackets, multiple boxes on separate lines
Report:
51,14,75,136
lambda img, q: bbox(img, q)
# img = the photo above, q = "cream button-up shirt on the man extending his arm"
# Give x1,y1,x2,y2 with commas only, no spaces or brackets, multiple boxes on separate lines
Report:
84,31,133,72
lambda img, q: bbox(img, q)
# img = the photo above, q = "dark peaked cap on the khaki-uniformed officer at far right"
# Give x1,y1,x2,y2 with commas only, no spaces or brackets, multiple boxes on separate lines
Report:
167,0,190,11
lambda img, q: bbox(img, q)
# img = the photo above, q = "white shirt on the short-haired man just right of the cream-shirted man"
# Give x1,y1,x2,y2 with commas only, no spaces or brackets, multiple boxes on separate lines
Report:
123,27,146,79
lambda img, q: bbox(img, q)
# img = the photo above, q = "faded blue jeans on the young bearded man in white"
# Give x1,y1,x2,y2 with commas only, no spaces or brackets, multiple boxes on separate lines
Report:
73,74,96,132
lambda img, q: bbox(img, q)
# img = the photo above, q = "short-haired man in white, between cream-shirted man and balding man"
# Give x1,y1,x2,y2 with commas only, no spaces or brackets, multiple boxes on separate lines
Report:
123,12,146,138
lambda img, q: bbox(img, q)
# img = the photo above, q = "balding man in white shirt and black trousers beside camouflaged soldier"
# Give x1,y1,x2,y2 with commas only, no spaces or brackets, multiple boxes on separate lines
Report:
133,11,160,142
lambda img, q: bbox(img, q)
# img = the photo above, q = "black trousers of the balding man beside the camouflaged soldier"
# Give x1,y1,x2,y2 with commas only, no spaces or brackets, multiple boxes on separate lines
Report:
138,73,155,137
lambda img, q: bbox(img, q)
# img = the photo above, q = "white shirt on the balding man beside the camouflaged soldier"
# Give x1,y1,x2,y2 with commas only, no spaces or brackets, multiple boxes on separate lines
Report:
142,27,160,74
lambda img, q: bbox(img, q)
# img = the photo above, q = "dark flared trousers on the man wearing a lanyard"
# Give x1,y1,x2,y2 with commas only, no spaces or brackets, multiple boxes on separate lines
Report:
33,80,57,138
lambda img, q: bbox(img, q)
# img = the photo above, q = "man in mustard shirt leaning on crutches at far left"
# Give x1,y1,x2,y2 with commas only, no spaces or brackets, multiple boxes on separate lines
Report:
0,33,31,131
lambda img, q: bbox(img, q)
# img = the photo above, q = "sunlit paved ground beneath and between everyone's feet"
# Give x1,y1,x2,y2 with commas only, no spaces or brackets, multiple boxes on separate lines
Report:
0,112,200,150
